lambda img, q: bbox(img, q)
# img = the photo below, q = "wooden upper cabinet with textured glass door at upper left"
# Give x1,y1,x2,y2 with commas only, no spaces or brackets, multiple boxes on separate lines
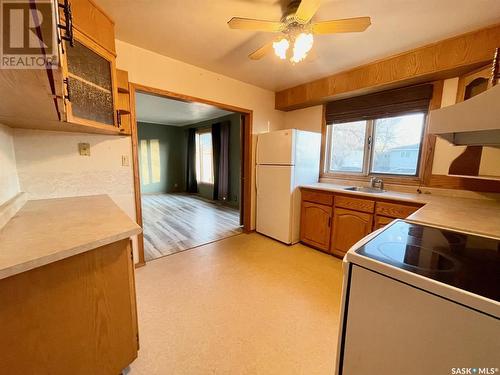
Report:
0,0,119,134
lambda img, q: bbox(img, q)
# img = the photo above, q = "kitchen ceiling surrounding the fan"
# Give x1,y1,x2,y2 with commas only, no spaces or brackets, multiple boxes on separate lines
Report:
98,0,500,91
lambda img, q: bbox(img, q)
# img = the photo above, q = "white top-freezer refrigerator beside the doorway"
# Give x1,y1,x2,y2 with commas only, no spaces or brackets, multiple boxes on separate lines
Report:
256,129,321,244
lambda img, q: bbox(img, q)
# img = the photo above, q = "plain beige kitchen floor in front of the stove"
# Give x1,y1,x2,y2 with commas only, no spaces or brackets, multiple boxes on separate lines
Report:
126,233,342,375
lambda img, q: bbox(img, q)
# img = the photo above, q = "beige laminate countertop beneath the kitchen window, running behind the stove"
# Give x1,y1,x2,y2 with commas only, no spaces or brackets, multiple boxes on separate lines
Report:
301,182,500,239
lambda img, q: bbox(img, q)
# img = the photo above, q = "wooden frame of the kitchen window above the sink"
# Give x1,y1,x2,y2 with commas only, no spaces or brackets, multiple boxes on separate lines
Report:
320,110,429,185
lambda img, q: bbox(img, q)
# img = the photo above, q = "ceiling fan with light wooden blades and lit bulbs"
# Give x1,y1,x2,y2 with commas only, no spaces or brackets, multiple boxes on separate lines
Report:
227,0,371,63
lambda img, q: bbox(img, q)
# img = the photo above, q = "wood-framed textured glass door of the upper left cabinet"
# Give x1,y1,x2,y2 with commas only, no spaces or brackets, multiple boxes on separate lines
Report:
63,30,117,127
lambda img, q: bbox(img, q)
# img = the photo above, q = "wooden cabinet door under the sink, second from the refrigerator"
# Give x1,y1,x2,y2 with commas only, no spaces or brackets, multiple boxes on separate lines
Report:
332,208,373,257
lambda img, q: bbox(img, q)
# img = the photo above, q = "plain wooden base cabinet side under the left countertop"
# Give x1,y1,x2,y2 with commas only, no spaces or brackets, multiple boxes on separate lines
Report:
0,239,138,375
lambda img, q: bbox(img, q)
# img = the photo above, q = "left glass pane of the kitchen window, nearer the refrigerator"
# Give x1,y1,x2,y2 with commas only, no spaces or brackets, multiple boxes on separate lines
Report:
330,121,366,173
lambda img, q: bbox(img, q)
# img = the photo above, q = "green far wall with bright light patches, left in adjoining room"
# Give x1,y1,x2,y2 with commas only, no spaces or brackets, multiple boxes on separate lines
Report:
137,122,187,194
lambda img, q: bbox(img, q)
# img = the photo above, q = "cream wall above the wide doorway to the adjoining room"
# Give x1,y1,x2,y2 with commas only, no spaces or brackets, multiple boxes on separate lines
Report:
116,40,284,226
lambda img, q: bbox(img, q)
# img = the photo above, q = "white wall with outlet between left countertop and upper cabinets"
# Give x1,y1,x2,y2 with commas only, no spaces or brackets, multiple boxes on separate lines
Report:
13,129,137,258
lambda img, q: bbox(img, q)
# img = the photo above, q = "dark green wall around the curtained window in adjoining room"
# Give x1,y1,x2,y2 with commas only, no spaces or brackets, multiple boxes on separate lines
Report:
184,113,241,206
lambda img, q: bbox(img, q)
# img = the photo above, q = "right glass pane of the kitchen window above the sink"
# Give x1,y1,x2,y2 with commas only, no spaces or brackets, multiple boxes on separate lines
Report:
371,113,425,175
